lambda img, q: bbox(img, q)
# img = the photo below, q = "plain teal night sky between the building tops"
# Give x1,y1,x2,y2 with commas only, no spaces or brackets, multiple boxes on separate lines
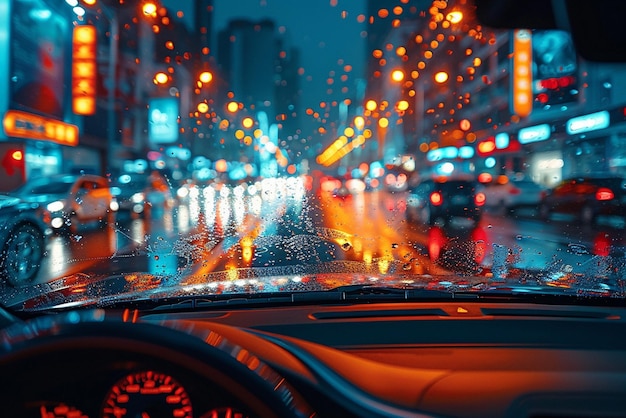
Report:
158,0,367,106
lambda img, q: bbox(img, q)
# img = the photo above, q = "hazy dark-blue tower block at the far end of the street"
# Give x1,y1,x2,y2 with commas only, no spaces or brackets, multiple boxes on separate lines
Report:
217,19,300,168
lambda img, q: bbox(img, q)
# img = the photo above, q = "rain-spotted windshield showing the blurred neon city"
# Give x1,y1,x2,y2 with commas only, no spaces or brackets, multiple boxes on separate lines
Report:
0,0,626,310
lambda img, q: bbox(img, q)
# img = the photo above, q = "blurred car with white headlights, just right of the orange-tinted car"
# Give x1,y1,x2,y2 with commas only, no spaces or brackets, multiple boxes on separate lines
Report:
111,171,174,217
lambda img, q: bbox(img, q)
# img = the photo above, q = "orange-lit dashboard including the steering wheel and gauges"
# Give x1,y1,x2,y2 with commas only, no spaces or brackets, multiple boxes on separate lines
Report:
0,300,626,418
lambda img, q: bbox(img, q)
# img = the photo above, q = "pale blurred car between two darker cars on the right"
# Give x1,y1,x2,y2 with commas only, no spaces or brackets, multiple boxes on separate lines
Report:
482,176,546,213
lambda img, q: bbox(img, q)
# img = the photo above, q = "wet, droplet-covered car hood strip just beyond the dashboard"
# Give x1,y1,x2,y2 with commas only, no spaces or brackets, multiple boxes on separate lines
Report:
2,261,625,311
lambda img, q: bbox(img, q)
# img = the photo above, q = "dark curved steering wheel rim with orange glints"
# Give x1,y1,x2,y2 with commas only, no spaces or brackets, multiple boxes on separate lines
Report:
0,317,310,418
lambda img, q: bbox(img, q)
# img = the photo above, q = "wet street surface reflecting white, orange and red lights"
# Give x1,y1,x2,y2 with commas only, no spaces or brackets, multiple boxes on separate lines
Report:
2,185,626,306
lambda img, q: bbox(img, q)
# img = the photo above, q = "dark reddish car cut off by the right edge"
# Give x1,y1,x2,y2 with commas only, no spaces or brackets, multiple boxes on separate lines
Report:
539,176,626,224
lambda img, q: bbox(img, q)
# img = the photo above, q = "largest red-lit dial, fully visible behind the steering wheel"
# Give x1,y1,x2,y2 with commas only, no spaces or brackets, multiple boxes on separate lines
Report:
102,371,192,418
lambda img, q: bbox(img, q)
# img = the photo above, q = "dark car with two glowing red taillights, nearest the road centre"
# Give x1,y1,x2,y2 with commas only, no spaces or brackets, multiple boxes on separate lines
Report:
406,178,485,225
